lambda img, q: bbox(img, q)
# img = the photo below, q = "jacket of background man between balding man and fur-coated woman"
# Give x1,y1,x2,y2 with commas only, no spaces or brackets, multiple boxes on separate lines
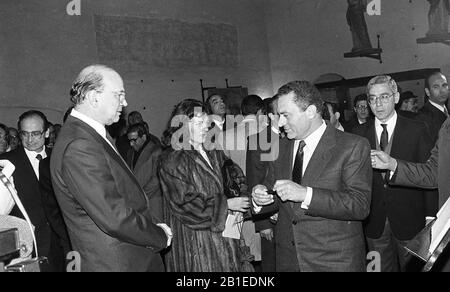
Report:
127,140,163,222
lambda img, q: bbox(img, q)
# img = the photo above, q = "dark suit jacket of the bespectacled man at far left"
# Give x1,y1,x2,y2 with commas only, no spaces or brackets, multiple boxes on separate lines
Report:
0,146,52,257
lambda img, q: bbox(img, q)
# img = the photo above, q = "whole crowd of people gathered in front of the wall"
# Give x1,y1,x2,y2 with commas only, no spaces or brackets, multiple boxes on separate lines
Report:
0,65,450,272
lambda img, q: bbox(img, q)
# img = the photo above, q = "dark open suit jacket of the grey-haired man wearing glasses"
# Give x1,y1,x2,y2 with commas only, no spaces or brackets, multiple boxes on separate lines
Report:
355,115,432,240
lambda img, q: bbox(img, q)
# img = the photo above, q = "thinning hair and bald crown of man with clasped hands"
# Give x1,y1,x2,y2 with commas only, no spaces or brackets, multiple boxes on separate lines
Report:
70,65,114,105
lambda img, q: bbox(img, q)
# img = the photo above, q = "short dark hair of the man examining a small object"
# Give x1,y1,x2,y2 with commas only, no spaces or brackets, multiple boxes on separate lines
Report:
277,81,323,114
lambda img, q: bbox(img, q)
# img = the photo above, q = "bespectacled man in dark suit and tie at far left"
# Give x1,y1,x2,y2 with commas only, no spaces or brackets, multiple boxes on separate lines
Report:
1,111,65,272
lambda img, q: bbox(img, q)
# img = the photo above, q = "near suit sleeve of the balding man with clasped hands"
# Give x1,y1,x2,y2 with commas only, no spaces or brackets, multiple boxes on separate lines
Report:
62,140,167,251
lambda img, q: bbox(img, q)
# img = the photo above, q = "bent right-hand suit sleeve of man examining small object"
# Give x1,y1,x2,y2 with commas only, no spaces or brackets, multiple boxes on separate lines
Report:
306,139,372,221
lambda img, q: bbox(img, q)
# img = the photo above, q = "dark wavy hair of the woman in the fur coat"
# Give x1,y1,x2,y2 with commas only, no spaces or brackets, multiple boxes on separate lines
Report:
161,99,206,148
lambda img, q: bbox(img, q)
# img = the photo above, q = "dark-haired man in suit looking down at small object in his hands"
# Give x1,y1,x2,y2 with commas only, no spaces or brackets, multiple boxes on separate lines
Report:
252,81,372,271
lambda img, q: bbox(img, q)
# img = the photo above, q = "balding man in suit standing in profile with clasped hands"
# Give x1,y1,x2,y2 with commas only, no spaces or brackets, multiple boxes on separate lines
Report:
50,65,171,271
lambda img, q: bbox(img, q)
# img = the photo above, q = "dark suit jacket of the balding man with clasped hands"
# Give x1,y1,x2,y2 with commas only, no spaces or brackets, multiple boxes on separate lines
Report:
50,116,167,271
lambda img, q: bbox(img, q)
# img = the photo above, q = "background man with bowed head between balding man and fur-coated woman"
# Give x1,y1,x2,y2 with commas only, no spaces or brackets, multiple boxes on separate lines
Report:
127,123,163,223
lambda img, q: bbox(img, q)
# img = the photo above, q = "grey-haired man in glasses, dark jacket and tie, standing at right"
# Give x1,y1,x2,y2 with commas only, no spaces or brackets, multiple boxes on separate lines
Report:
354,75,435,272
